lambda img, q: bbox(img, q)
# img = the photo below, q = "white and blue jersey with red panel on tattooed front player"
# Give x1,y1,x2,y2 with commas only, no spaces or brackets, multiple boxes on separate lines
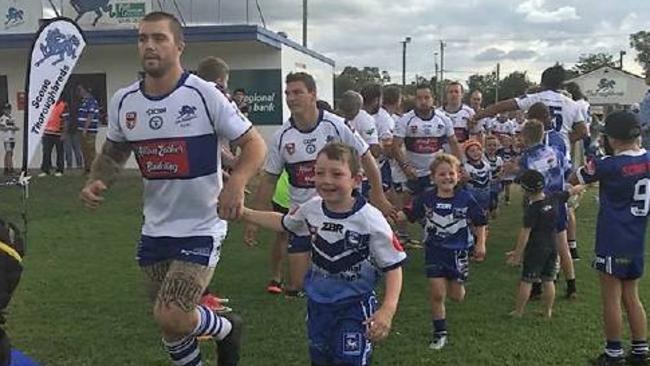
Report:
107,73,252,237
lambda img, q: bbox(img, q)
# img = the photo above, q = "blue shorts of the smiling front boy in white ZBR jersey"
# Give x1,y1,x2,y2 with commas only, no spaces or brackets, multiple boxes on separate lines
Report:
307,293,377,366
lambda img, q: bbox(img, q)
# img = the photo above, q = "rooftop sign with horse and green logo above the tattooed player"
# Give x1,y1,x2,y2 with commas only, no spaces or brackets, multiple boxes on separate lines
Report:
63,0,151,29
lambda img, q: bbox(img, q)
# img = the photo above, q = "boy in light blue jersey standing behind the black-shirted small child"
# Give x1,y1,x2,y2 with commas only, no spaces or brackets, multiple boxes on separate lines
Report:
519,120,577,299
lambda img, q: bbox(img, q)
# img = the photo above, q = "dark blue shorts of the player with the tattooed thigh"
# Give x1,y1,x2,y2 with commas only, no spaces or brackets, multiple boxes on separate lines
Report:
136,235,224,267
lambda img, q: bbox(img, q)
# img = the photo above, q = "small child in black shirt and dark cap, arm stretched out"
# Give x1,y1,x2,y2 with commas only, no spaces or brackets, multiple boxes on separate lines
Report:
507,170,581,319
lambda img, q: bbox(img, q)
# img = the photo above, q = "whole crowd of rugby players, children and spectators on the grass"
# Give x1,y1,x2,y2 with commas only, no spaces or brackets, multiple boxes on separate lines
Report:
0,12,650,366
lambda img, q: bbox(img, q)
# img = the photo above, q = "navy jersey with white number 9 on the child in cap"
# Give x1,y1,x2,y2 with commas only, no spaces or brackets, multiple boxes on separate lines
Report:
576,149,650,259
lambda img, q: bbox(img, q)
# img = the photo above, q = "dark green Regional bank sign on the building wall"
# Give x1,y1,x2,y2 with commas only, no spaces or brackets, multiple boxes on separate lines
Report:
228,70,283,125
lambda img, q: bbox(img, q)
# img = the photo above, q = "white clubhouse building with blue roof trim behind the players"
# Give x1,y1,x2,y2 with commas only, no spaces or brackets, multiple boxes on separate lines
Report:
0,0,334,167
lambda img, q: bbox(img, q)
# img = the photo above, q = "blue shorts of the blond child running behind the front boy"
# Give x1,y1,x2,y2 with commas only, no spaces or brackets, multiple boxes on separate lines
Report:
425,245,469,283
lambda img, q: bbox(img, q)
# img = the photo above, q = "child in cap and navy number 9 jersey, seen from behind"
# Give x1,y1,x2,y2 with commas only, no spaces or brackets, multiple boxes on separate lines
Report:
570,112,650,365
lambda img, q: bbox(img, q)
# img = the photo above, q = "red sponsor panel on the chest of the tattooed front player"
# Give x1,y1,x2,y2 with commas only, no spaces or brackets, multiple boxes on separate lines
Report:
133,140,190,178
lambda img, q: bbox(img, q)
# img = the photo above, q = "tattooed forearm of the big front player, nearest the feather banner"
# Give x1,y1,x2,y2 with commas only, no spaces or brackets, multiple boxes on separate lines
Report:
89,140,131,186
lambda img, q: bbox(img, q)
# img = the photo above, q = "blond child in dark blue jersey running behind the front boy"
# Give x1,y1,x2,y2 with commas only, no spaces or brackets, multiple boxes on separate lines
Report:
400,154,487,350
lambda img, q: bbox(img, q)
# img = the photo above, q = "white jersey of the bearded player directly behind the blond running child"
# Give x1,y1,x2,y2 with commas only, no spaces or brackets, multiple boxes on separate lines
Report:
394,110,454,177
